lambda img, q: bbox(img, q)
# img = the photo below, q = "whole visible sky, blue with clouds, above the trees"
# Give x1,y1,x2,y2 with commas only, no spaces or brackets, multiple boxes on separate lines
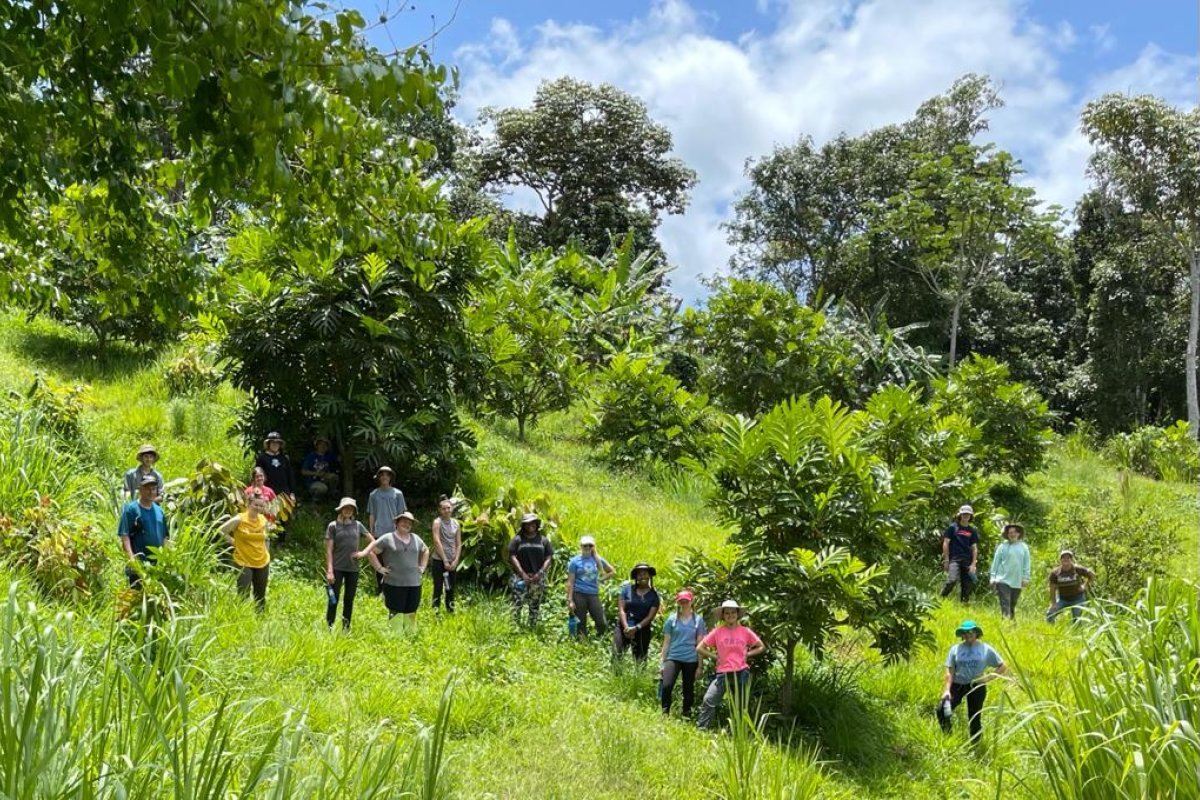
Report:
349,0,1200,301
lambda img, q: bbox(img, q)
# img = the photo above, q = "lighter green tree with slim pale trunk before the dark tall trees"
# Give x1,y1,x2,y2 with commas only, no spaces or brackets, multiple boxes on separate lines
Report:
886,145,1056,369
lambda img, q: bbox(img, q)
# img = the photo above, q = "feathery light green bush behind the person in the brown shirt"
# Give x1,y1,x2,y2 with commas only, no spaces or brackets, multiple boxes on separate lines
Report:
1048,487,1178,602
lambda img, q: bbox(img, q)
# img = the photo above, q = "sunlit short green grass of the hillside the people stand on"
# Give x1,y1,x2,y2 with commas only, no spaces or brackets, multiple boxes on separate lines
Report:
0,318,1196,800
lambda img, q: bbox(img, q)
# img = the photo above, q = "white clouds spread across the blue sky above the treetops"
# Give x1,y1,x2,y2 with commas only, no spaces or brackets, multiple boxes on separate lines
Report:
457,0,1194,299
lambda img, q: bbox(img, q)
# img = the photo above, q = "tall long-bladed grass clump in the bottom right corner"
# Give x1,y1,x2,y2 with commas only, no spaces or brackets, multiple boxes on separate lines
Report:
1014,582,1200,800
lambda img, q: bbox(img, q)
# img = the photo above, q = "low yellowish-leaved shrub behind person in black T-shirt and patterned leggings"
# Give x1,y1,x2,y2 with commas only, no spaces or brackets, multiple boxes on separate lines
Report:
460,486,568,589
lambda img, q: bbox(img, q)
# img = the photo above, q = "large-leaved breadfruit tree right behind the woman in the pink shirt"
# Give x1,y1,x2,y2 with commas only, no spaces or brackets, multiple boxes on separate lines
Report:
680,397,932,710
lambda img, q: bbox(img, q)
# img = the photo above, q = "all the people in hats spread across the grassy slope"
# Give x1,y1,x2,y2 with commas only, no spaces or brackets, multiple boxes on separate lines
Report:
118,443,1094,741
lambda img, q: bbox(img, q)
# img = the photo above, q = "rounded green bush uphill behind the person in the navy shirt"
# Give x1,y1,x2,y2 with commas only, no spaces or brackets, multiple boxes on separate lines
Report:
934,355,1051,483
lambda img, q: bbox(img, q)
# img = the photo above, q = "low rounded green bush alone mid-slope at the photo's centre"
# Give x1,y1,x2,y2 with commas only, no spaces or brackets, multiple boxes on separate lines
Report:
586,353,710,468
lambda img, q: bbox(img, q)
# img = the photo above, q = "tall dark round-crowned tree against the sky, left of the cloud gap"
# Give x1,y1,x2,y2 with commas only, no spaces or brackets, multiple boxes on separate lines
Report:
465,78,696,255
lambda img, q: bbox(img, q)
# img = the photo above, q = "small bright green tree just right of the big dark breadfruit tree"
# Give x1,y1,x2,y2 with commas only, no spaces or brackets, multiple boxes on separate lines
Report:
468,236,582,440
